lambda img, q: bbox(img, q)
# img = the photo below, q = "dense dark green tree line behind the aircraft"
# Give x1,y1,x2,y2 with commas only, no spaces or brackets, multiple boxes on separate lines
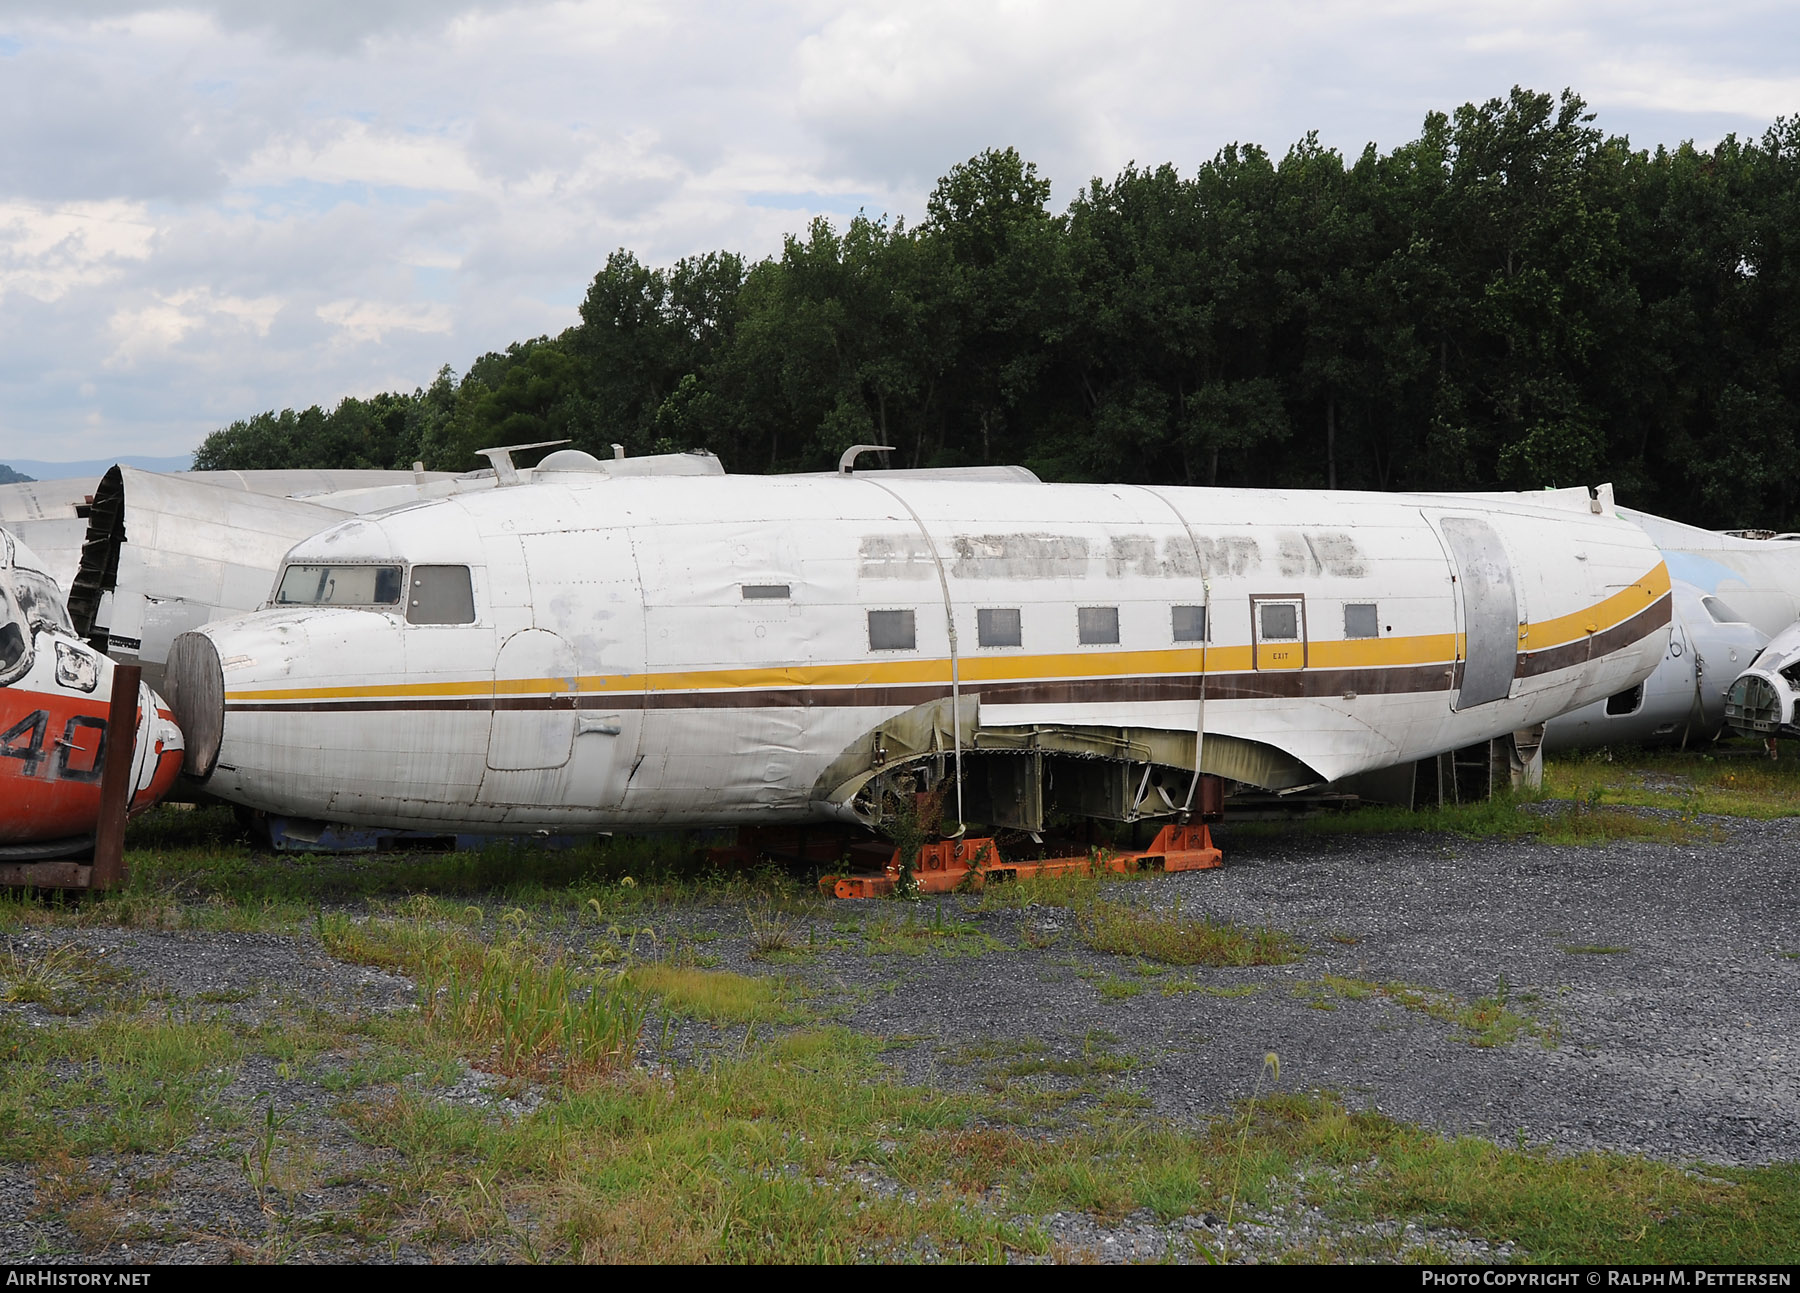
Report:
194,88,1800,529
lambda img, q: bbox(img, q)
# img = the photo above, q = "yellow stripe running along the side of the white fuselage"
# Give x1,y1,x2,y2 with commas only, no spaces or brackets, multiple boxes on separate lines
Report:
227,562,1669,701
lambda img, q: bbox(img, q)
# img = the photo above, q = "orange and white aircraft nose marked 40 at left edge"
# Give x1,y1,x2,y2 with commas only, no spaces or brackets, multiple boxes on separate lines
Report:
0,529,184,857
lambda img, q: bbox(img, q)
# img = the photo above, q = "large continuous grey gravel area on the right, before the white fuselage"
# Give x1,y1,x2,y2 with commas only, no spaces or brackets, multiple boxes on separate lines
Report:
648,818,1800,1165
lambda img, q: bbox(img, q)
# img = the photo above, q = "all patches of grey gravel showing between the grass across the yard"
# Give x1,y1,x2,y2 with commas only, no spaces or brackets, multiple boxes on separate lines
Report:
0,819,1800,1261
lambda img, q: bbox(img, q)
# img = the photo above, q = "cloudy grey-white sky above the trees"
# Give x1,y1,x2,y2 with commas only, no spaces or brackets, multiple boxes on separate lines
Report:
0,0,1800,461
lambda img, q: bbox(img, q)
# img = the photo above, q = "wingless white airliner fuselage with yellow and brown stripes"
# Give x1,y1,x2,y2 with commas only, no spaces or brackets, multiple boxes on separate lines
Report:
166,472,1670,832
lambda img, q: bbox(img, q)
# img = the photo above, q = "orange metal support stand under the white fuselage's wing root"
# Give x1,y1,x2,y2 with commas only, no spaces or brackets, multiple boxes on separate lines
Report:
819,823,1224,899
